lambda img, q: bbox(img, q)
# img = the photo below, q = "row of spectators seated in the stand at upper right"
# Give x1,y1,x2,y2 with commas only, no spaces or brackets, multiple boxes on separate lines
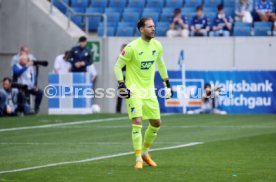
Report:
167,0,276,37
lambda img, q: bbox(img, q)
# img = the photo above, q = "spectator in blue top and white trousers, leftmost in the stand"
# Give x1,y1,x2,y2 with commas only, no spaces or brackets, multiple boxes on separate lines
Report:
167,8,189,38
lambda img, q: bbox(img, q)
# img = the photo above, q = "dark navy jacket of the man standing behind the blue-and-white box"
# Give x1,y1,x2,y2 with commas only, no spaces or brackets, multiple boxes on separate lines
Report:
69,46,92,72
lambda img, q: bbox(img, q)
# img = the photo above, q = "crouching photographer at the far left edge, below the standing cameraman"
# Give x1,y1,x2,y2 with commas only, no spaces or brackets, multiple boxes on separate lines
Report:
0,77,18,116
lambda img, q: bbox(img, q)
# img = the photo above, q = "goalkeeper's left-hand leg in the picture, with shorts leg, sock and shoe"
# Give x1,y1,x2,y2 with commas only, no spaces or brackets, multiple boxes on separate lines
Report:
126,98,143,169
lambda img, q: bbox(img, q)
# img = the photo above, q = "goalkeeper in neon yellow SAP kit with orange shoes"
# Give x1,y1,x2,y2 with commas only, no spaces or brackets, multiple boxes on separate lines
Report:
114,17,173,169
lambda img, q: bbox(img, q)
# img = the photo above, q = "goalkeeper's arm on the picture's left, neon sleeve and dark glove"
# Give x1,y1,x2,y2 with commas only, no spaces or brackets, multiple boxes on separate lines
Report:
114,46,133,99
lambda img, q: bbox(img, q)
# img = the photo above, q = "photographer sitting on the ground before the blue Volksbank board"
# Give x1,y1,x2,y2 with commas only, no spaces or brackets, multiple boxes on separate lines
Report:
187,83,226,114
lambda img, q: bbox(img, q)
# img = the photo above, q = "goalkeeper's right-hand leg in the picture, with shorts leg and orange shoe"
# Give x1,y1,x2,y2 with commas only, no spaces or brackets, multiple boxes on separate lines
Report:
142,98,161,167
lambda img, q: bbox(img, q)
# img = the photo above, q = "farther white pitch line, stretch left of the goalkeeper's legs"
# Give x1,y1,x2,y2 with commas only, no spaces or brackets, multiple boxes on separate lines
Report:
0,117,128,132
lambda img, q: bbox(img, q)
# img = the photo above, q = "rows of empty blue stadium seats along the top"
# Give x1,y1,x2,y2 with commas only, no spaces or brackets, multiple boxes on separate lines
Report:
53,0,276,36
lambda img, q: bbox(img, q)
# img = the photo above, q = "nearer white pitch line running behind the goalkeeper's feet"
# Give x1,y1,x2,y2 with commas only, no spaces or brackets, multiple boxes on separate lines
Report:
0,142,203,174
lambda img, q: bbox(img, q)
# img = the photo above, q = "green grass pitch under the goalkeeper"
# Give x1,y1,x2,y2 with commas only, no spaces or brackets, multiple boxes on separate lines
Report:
0,114,276,182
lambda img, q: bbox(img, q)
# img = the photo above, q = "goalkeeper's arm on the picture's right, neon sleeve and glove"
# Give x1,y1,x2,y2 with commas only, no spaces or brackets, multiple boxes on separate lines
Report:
157,46,173,99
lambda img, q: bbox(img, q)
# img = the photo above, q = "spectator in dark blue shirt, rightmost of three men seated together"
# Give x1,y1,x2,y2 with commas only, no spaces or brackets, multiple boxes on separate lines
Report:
212,4,233,36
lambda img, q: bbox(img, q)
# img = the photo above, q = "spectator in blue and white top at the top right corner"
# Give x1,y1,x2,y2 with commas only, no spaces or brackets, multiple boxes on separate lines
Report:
256,0,276,21
